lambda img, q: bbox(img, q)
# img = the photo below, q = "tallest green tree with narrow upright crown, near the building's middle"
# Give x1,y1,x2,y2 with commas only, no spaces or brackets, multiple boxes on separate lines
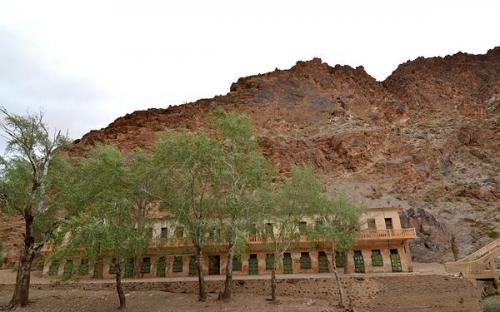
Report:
214,109,272,301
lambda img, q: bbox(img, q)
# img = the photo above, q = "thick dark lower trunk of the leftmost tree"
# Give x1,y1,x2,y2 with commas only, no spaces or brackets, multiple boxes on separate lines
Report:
7,214,35,309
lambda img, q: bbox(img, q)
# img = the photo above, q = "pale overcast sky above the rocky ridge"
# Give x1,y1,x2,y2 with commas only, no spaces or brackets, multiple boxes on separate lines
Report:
0,0,500,146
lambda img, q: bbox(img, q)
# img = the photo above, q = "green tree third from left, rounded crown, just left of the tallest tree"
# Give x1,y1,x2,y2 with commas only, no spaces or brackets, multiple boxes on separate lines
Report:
152,132,222,301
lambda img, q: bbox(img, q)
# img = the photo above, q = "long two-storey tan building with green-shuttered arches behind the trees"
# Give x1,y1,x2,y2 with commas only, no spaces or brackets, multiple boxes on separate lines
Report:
43,207,416,278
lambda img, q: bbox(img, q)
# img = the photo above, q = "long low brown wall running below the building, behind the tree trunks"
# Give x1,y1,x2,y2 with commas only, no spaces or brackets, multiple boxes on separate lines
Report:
1,274,482,312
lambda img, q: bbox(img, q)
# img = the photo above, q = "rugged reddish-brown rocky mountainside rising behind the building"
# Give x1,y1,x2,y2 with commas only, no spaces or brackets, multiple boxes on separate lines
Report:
0,47,500,261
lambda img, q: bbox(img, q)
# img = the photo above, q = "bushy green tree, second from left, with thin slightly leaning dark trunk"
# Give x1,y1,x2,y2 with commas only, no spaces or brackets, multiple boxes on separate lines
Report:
53,146,150,309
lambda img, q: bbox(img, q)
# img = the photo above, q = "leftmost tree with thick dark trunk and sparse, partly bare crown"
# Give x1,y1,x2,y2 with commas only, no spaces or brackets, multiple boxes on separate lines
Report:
0,108,68,308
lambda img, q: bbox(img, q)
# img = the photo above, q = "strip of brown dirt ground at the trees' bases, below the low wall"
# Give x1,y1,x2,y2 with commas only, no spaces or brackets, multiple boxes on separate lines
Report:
0,289,340,312
